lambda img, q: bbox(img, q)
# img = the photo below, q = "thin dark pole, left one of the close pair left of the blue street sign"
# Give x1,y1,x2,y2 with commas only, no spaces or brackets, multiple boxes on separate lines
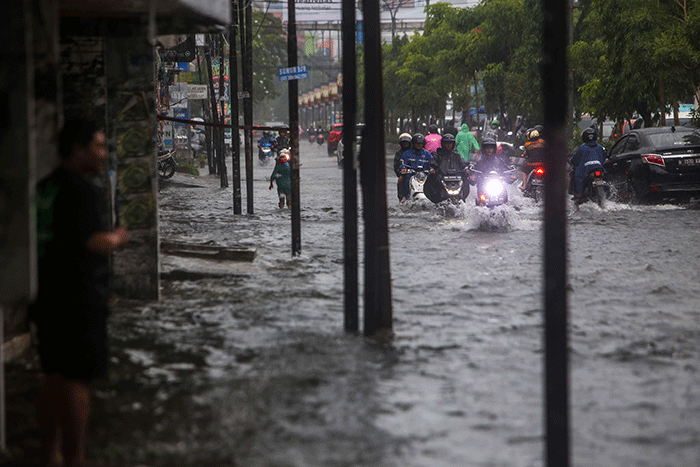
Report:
228,1,242,214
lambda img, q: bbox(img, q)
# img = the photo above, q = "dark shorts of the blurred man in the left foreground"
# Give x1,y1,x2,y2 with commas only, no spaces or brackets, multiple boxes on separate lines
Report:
35,305,109,382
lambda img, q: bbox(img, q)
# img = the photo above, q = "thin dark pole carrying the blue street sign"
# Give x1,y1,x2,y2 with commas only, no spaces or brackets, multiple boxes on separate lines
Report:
287,0,301,256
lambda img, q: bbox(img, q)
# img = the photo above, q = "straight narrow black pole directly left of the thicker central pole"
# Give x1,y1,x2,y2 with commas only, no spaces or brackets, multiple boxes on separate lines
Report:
342,0,359,332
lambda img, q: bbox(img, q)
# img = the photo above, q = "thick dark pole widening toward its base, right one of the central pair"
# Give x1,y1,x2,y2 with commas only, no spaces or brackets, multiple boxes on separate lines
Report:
360,0,392,336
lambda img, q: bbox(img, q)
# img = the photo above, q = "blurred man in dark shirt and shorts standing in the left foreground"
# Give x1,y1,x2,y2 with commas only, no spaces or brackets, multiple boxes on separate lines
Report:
29,120,129,466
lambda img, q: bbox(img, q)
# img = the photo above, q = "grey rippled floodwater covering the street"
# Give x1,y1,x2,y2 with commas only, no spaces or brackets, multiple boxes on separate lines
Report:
12,141,700,467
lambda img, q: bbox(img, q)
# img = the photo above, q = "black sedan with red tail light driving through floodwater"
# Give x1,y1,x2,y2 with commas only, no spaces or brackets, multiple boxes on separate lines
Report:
604,127,700,203
